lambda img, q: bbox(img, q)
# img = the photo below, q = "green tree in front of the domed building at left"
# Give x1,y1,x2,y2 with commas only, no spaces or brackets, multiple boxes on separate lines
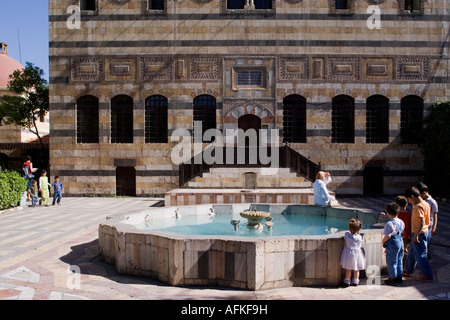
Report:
0,62,49,149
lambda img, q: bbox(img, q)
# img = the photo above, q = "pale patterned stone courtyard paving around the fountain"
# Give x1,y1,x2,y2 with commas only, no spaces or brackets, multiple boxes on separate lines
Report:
0,197,450,301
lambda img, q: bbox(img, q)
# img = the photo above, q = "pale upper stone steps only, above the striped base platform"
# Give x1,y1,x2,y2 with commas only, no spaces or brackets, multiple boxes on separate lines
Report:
186,167,312,189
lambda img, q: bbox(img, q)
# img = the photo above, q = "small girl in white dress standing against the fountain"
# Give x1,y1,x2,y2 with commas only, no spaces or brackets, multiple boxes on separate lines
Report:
341,218,366,287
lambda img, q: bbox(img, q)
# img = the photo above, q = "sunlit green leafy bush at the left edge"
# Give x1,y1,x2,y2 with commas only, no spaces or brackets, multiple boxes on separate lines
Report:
0,170,27,210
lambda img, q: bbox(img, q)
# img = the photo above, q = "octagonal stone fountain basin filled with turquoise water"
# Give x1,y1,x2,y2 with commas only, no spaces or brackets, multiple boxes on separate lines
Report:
99,204,386,290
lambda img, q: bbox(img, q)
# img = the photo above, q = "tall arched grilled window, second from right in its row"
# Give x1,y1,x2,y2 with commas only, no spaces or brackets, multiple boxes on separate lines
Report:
366,95,389,143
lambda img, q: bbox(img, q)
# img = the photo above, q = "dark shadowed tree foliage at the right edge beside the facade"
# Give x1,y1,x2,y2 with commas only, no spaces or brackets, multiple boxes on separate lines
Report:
421,101,450,197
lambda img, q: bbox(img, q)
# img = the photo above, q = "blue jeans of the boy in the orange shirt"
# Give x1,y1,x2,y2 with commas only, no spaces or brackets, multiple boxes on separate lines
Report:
405,233,433,279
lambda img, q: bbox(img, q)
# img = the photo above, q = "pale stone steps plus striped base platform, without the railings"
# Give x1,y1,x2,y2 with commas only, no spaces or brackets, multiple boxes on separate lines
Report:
165,167,314,206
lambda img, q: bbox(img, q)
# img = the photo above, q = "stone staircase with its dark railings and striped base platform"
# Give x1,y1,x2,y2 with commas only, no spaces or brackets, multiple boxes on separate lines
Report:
168,146,320,206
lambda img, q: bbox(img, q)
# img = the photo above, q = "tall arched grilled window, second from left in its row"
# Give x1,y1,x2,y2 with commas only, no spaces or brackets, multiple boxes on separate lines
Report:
111,95,133,143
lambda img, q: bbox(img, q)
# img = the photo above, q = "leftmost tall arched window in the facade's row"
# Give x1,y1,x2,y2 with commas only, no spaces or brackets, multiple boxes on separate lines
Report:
76,95,99,143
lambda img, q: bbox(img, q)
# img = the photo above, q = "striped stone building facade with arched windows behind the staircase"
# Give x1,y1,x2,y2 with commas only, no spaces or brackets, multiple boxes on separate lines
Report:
49,0,450,196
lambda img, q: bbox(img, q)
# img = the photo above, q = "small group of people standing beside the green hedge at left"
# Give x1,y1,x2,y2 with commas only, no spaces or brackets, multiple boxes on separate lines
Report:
22,156,63,207
